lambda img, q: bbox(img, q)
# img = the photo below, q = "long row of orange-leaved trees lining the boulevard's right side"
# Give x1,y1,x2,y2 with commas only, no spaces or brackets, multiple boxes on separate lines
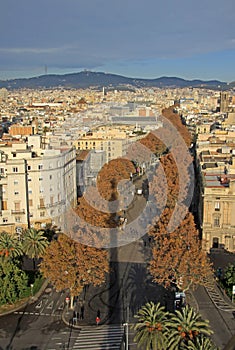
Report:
149,107,212,290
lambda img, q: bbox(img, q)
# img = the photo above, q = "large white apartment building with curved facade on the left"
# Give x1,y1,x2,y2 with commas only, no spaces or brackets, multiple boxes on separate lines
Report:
0,142,77,232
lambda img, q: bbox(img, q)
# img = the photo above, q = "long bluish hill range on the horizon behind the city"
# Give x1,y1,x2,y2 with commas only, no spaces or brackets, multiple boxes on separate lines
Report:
0,71,229,89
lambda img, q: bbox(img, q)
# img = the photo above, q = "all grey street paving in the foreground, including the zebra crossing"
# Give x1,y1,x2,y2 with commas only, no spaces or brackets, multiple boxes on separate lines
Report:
0,178,235,350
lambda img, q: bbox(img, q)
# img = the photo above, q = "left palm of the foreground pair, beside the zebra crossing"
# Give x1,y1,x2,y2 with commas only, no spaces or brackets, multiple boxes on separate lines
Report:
134,301,169,350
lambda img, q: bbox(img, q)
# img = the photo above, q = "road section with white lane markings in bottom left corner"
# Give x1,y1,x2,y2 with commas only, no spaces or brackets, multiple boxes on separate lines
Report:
0,288,78,350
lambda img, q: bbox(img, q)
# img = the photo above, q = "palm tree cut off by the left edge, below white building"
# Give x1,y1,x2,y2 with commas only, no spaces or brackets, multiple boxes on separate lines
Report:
0,231,23,258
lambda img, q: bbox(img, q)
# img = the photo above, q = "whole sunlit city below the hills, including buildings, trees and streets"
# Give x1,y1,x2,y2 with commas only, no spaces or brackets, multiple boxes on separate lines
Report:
0,85,235,350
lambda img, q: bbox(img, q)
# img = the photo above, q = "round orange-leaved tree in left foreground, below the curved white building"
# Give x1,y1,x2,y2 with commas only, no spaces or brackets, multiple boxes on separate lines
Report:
40,234,109,305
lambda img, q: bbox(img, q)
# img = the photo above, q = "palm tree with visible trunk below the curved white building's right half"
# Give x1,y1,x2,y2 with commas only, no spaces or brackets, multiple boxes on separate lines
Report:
23,228,49,270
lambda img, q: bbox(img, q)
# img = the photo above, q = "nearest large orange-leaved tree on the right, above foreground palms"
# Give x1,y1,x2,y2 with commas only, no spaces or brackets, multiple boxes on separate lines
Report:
149,213,212,291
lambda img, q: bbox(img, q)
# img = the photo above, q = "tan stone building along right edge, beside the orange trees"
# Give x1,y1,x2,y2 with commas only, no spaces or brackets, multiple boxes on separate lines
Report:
196,137,235,252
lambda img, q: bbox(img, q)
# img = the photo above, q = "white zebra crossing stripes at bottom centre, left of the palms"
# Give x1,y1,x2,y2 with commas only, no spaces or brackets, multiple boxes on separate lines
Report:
72,325,124,350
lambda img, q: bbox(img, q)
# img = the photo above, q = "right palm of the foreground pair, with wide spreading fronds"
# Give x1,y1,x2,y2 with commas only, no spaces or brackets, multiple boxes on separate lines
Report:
168,305,213,350
